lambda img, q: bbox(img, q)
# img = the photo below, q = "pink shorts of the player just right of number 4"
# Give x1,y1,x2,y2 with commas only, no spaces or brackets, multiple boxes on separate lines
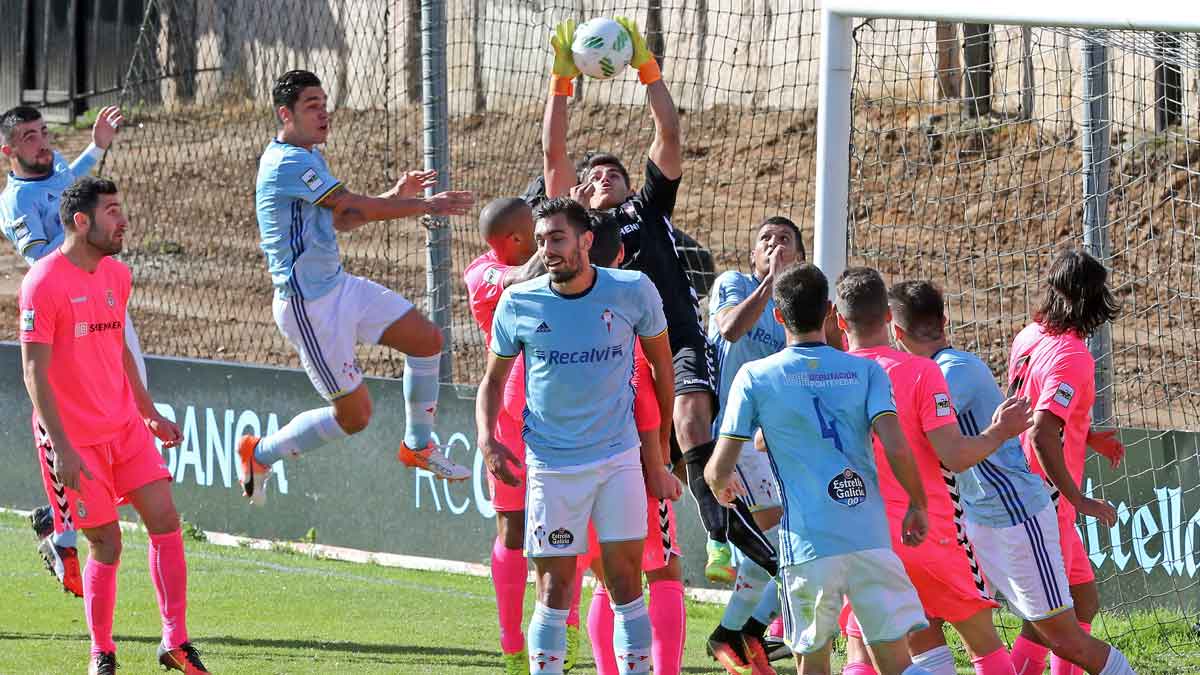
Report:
892,522,1000,623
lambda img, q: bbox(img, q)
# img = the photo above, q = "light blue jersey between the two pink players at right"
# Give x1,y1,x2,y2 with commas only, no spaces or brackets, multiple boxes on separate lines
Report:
934,347,1050,528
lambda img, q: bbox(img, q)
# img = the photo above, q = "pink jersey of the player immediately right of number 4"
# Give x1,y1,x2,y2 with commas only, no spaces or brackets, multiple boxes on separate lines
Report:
850,347,958,526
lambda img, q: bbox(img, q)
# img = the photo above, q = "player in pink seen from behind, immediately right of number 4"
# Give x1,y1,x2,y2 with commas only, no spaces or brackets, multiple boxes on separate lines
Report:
836,268,1030,675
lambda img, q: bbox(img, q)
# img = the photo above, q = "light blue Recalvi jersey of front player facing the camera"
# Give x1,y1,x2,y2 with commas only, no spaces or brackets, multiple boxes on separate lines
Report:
491,268,667,468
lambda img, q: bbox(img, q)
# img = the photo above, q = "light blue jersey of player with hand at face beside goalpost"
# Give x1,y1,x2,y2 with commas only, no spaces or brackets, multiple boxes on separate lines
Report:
708,265,787,434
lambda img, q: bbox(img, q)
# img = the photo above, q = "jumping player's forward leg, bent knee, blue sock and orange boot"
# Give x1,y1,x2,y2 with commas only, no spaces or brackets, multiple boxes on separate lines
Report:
379,309,470,480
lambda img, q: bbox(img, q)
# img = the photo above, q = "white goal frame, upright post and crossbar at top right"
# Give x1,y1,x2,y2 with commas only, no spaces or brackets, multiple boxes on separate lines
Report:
814,0,1200,283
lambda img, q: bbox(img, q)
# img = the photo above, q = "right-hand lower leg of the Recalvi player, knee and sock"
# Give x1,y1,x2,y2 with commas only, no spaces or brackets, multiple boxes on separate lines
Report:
600,539,653,673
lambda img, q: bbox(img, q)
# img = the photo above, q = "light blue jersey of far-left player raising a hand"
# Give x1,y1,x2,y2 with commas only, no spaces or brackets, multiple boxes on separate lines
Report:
0,147,101,264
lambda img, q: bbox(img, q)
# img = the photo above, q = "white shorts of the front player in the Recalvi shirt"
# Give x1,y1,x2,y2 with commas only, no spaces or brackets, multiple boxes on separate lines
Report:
524,447,647,557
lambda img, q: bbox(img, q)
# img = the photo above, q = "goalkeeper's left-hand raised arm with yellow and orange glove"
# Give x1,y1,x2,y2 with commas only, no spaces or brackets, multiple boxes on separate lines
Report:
541,19,580,199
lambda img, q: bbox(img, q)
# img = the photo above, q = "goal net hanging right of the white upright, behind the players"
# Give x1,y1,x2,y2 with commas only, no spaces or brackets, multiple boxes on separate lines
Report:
818,6,1200,658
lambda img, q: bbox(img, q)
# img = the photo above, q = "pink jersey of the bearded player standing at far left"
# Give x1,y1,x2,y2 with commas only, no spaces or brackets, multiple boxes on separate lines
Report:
20,250,139,446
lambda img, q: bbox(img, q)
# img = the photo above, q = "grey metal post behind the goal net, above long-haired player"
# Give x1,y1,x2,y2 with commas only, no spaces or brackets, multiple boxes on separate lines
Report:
1082,38,1112,423
